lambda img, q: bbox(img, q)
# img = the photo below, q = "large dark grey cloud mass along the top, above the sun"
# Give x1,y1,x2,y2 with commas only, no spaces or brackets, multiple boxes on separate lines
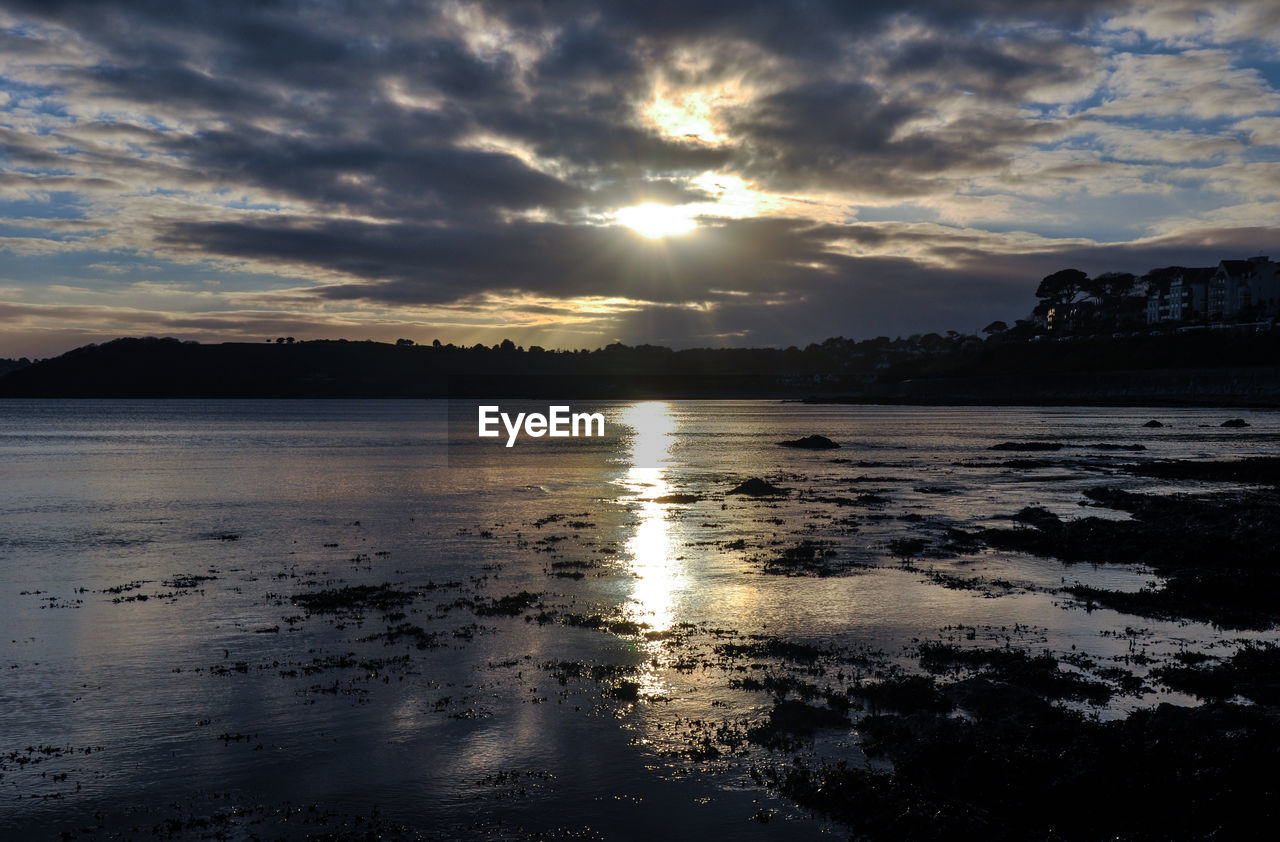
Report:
8,3,1111,209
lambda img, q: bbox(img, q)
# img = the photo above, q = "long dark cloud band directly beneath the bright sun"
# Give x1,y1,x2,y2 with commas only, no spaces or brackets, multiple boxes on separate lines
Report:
154,219,837,305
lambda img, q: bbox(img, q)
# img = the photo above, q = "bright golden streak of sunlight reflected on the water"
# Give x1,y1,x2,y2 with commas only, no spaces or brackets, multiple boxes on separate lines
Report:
618,401,685,694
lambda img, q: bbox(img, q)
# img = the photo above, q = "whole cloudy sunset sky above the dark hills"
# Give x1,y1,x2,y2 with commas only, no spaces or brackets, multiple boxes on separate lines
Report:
0,0,1280,357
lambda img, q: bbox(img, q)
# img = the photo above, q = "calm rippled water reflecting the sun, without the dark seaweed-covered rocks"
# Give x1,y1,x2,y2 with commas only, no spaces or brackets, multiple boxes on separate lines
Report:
0,401,1280,838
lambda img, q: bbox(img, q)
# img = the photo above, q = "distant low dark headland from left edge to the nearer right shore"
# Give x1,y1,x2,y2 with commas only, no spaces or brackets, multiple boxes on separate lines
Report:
0,338,859,398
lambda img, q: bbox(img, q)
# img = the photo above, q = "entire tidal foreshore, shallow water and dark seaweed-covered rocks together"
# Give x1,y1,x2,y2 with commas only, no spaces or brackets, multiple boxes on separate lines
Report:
0,401,1280,839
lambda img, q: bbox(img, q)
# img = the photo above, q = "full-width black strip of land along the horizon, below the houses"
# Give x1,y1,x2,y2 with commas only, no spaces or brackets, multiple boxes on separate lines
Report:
0,330,1280,406
